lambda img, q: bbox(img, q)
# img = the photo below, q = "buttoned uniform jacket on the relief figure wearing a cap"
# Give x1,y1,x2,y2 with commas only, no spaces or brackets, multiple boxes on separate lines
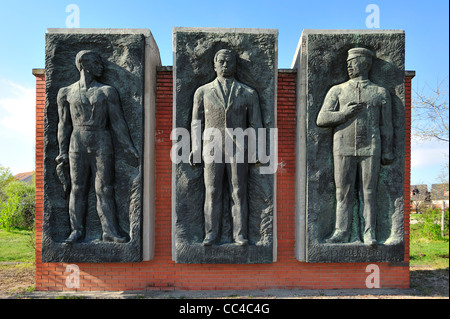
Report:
317,80,393,157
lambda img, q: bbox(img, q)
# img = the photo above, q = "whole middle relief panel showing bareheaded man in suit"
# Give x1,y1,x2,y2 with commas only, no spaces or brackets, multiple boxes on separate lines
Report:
172,28,277,263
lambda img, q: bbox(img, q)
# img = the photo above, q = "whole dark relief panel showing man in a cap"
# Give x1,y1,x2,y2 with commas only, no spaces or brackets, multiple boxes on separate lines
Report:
297,30,405,262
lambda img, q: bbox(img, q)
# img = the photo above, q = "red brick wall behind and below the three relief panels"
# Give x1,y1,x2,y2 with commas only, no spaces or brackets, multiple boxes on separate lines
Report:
32,68,411,291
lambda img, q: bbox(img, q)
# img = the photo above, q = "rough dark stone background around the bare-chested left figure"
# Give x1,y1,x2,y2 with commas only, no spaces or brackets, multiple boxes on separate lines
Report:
42,33,145,262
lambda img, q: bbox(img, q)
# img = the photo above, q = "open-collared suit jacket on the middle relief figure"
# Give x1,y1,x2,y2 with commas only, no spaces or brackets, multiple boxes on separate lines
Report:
191,78,263,161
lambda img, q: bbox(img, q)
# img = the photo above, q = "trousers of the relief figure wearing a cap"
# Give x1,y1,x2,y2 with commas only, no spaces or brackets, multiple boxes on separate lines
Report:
334,155,380,238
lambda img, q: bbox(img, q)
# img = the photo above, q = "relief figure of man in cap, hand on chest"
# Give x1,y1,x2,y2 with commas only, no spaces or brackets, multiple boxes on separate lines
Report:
317,48,394,246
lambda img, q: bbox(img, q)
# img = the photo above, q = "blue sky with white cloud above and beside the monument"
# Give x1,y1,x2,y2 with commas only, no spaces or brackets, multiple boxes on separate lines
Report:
0,0,449,188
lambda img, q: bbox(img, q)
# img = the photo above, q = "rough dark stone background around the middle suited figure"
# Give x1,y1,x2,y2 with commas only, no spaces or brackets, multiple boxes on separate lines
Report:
174,28,278,263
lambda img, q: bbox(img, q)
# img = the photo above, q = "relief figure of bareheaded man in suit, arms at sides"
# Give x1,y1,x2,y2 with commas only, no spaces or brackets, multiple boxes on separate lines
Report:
190,49,262,246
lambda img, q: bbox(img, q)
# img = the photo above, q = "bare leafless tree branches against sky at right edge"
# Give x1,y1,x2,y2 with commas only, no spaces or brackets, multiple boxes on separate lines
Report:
412,76,449,143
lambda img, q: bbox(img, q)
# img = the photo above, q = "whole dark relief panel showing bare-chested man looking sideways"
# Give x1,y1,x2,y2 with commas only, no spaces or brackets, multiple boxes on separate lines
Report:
42,33,145,262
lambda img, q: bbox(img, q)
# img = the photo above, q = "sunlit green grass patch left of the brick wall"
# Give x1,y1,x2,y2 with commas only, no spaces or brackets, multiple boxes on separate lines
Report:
0,229,35,262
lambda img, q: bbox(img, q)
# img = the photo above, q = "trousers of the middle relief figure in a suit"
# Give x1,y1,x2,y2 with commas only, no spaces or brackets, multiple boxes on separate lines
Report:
204,163,248,239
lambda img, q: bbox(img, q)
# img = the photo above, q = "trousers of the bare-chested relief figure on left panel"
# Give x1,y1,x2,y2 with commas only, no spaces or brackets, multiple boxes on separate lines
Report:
69,153,118,236
